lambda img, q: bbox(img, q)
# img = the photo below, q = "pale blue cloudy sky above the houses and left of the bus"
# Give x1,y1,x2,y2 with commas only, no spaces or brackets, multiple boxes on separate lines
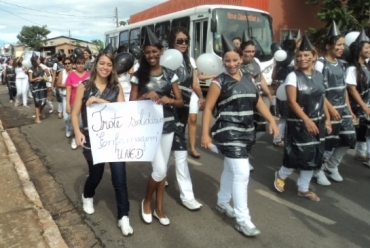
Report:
0,0,165,46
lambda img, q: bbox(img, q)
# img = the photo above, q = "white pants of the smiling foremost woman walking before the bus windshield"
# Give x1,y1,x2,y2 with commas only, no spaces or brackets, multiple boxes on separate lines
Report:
217,157,254,226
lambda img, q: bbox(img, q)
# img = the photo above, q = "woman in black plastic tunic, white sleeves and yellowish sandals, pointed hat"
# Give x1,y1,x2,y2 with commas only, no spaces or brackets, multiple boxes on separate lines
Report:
274,36,331,201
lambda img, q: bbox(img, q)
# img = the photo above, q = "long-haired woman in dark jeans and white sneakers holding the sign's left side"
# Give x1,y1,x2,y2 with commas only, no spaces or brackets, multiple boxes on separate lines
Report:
72,45,134,236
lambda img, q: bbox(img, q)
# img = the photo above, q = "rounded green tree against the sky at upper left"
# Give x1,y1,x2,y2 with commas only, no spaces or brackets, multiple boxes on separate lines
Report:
17,26,50,50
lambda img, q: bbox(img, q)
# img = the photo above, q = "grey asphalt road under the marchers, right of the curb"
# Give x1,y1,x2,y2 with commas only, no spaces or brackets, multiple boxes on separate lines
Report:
0,86,370,248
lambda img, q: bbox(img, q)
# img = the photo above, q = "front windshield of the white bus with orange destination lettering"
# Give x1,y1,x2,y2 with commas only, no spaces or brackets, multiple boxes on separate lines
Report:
212,9,273,62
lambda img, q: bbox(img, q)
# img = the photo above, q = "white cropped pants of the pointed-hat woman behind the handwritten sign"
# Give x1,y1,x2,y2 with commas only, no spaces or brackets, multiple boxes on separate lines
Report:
152,132,174,182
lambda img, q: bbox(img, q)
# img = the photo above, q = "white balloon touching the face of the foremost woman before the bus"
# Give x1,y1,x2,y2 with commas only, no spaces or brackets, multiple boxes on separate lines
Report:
197,53,222,75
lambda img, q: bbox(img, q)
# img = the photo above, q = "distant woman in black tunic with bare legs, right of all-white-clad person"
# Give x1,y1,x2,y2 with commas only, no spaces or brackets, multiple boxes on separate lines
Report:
28,53,50,124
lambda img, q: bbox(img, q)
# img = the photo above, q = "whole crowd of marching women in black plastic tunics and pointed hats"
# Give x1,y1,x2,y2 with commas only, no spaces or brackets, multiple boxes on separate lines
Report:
0,22,370,239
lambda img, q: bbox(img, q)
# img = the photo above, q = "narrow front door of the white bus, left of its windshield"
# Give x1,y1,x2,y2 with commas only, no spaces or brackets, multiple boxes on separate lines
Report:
191,18,208,59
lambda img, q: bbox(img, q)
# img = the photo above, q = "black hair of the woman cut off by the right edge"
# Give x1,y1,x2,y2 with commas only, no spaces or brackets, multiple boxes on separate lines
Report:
349,41,370,89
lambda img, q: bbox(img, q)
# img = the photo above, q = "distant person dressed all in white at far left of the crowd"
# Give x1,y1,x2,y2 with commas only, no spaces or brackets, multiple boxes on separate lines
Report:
14,57,29,108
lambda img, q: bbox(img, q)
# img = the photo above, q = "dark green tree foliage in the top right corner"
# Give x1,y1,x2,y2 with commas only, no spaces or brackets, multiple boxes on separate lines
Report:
304,0,370,43
